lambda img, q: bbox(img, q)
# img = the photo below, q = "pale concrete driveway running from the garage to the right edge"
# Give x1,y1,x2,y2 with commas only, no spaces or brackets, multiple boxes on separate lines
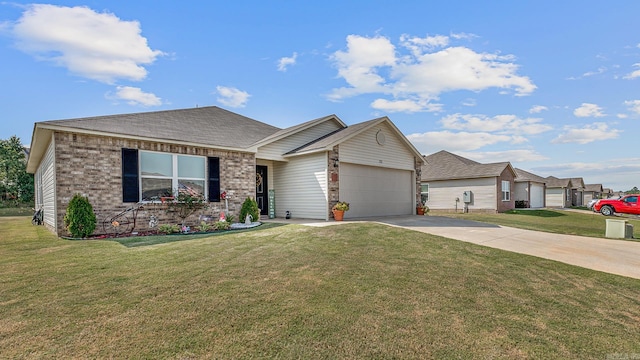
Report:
269,216,640,279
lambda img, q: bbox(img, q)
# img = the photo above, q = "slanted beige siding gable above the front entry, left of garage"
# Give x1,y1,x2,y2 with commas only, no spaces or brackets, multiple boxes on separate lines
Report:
256,121,340,161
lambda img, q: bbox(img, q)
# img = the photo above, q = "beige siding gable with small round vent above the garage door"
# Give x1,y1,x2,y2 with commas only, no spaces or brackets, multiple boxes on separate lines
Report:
339,123,415,171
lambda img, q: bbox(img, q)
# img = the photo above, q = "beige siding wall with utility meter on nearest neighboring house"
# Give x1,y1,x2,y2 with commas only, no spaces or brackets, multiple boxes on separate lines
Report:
427,178,498,210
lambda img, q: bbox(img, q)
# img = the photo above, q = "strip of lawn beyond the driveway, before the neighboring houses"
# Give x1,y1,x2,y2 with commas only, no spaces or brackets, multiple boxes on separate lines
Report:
430,209,640,239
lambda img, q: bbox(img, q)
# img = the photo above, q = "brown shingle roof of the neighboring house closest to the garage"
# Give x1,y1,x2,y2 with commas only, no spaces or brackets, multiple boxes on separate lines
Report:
421,150,511,181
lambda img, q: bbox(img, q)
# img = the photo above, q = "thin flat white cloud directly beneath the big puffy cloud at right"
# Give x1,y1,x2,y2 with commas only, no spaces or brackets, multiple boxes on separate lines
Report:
440,114,552,135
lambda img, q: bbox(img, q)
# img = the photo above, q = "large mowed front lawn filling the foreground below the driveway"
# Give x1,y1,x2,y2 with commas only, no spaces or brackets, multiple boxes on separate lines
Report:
0,217,640,359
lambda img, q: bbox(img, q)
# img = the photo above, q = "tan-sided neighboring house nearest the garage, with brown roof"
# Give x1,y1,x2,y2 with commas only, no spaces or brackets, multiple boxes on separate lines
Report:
421,150,516,212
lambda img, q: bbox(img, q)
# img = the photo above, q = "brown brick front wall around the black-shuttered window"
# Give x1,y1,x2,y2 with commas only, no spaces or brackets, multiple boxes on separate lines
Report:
55,132,256,235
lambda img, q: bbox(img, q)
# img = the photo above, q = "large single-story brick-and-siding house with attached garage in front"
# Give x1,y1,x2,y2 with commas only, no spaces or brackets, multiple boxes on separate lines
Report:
27,106,422,234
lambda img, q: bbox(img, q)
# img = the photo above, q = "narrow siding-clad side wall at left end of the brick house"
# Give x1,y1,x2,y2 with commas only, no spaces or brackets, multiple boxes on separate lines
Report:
35,136,56,229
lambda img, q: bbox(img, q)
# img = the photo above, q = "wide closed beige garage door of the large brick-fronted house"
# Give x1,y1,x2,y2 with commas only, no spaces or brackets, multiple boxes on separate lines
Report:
340,163,415,219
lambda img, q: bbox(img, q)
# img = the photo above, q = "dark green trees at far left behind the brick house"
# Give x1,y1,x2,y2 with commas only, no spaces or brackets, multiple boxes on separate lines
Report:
0,135,34,206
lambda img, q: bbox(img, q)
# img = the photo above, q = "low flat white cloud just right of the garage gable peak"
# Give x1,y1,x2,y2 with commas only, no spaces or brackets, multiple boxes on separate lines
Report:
407,131,513,154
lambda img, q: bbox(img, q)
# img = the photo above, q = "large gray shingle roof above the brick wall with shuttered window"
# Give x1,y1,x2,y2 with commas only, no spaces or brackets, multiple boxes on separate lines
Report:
38,106,281,149
